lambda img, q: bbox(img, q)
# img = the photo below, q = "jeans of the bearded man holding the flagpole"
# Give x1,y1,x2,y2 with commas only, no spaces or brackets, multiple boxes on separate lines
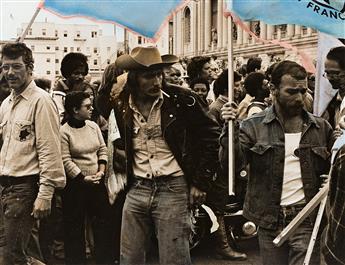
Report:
258,205,320,265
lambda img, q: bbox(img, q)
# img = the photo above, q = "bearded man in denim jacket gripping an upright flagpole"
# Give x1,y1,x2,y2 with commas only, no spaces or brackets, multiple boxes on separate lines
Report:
221,61,332,265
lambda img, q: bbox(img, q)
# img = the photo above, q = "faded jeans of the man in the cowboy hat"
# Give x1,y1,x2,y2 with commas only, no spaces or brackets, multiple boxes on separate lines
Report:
121,176,191,265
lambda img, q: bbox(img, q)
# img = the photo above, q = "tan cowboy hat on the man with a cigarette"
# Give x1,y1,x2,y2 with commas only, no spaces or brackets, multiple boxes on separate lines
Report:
115,47,178,70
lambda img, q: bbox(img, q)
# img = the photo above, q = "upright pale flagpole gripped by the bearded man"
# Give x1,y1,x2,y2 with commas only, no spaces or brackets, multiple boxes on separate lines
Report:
227,12,235,195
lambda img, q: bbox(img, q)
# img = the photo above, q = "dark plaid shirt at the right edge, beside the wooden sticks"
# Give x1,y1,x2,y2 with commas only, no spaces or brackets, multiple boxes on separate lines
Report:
323,145,345,265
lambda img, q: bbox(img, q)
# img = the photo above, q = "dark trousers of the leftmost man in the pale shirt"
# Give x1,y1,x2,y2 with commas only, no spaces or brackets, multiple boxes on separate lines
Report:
1,178,38,265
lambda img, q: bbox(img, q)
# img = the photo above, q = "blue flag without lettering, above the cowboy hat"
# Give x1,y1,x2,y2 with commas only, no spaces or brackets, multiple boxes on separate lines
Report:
42,0,184,38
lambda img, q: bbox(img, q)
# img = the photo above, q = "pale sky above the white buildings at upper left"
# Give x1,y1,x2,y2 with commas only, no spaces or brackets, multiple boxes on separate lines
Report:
0,0,123,41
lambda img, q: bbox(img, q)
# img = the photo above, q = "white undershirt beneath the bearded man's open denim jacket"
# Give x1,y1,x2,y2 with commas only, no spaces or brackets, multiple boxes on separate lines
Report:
280,133,305,206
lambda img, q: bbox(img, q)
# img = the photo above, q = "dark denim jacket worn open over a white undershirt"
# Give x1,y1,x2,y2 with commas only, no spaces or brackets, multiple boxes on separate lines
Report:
239,106,332,229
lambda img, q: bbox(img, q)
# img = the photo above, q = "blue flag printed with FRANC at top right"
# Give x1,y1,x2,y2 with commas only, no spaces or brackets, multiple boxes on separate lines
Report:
227,0,345,38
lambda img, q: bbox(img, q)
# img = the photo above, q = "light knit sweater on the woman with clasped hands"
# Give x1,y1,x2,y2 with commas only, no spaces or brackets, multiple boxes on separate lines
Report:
60,120,107,178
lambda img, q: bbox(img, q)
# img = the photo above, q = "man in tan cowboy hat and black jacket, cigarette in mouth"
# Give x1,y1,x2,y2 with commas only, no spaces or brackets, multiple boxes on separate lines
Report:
99,47,220,265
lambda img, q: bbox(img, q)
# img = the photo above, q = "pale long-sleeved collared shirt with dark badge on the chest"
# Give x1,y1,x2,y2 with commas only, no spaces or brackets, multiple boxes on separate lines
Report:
0,81,65,197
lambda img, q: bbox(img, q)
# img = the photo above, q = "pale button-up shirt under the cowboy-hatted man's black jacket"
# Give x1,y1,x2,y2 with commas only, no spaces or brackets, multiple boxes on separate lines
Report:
129,93,183,178
